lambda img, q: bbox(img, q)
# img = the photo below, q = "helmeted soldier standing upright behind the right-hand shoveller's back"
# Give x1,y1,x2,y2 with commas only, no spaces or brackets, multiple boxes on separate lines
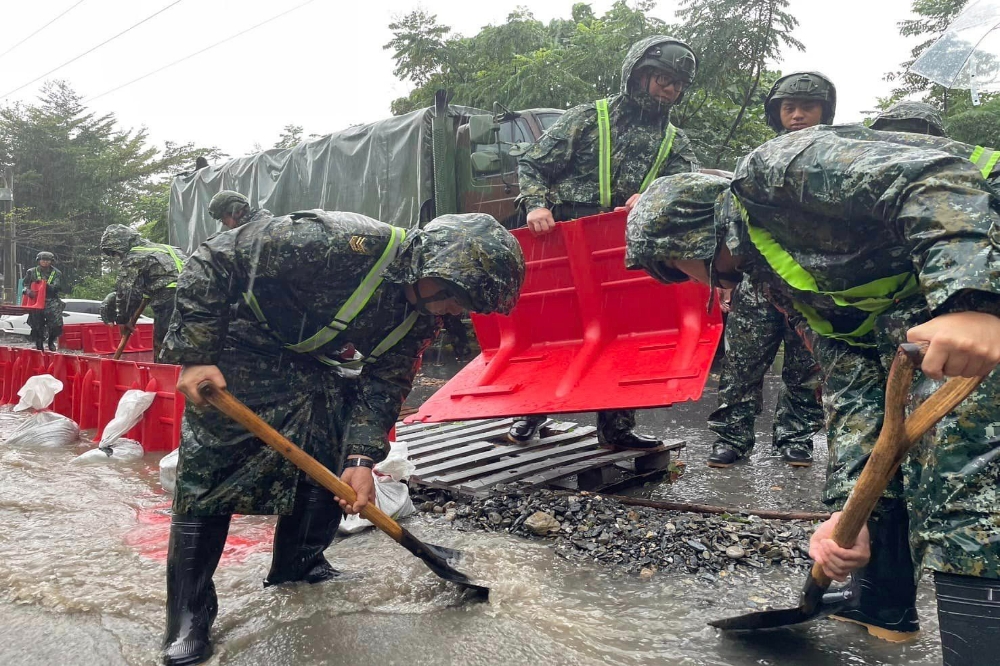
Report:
708,72,837,467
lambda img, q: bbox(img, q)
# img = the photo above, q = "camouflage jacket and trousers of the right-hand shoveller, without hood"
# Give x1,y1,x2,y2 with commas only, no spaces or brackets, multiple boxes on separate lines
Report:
728,126,1000,578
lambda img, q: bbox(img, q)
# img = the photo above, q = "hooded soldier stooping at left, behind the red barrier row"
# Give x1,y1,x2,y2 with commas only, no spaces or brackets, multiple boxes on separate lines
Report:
101,224,186,361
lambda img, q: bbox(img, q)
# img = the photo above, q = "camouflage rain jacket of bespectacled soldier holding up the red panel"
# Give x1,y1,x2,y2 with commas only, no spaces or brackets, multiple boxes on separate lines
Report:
517,35,698,219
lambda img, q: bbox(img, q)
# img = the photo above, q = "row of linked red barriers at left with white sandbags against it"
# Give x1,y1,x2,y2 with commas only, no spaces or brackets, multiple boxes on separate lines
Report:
0,342,184,452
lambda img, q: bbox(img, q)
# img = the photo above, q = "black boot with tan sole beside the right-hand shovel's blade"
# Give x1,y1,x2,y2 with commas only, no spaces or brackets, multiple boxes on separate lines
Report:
831,504,920,643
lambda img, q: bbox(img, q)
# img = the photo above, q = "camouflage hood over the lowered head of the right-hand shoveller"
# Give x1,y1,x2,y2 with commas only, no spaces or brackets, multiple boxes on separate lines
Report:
625,173,729,284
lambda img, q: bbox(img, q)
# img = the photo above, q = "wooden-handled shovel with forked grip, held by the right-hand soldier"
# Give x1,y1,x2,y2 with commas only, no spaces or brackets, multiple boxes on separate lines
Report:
709,344,983,631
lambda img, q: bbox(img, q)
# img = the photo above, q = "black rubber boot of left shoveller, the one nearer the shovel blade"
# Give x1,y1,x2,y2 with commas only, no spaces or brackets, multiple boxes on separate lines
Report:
264,483,344,587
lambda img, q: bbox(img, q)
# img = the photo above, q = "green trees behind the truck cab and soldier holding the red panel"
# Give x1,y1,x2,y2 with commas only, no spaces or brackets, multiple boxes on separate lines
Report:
384,0,802,167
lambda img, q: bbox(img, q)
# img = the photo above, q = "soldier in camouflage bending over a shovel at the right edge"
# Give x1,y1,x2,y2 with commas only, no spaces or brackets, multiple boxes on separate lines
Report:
628,126,1000,666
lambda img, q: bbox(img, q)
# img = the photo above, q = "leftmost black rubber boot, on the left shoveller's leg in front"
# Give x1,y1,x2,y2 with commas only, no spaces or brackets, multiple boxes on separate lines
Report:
161,515,231,666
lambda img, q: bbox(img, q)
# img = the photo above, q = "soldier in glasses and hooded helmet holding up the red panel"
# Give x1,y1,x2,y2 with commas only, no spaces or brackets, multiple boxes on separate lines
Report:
508,35,698,449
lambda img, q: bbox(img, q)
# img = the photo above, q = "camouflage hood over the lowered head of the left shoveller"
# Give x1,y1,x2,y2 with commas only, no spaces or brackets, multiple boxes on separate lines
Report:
384,213,525,314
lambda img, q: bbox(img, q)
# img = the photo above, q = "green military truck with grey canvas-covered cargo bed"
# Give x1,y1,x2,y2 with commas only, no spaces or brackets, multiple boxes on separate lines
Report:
168,91,562,252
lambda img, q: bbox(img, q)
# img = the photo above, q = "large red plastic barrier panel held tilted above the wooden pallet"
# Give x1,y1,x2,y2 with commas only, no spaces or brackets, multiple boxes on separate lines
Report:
406,212,722,422
